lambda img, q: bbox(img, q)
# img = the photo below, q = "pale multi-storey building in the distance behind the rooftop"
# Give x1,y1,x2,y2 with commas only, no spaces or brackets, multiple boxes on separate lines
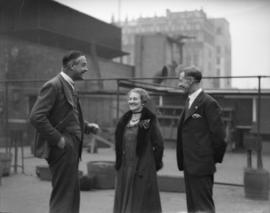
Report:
118,10,231,88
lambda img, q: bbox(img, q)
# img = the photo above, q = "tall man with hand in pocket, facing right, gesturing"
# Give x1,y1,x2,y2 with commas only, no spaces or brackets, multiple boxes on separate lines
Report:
30,51,99,213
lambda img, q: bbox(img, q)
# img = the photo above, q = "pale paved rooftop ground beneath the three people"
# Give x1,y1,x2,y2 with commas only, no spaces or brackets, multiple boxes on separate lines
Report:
0,146,270,213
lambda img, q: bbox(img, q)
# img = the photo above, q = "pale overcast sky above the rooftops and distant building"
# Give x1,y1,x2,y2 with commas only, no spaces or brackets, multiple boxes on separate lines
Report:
56,0,270,88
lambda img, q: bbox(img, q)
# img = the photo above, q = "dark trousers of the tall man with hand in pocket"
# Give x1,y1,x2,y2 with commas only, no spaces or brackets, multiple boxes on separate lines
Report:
48,134,80,213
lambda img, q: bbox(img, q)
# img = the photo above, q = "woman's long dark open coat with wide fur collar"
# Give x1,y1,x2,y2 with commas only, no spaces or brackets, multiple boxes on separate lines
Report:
115,107,164,213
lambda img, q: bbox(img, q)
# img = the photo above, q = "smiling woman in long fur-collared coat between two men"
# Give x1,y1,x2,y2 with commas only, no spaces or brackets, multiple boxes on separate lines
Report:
114,88,164,213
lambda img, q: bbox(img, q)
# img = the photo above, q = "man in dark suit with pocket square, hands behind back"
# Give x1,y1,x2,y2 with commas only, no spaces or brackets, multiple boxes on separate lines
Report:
177,66,226,213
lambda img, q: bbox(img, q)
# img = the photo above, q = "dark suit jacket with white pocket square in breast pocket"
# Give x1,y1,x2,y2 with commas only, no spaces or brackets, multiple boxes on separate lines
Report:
177,91,226,175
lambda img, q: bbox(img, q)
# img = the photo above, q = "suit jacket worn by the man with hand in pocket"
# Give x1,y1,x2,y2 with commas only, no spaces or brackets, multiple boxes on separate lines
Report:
30,74,84,158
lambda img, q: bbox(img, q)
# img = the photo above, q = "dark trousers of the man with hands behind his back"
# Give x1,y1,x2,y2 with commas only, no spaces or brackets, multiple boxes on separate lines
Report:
184,172,215,213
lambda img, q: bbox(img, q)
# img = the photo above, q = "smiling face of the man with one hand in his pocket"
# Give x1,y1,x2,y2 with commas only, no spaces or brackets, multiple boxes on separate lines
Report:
70,56,88,81
